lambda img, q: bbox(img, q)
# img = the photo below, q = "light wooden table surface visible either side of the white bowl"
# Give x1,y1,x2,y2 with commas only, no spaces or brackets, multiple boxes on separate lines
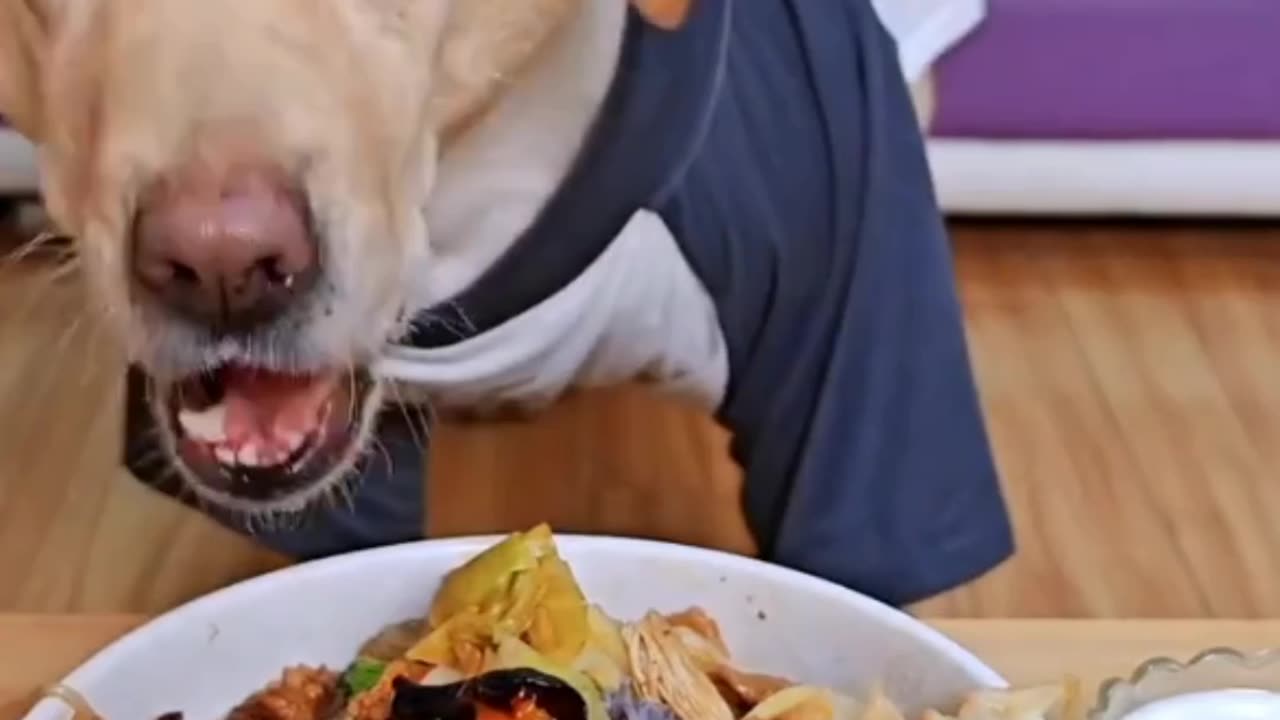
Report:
0,614,1280,720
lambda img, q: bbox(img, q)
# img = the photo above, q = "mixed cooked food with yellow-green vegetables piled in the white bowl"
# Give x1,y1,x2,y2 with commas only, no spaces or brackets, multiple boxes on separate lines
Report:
45,525,1084,720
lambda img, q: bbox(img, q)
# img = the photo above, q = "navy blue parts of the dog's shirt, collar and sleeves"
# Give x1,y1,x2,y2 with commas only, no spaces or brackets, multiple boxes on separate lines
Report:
125,0,1012,605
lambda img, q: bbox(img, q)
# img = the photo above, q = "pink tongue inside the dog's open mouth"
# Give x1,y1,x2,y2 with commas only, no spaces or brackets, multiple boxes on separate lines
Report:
221,368,335,443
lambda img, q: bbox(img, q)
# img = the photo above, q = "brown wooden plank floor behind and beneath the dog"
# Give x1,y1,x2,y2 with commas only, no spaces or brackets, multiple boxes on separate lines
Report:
0,224,1280,618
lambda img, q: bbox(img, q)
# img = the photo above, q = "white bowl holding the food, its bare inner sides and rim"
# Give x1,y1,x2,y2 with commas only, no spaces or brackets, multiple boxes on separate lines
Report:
27,536,1006,720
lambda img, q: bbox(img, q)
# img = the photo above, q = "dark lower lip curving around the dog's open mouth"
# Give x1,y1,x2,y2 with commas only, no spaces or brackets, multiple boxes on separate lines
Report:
161,361,375,503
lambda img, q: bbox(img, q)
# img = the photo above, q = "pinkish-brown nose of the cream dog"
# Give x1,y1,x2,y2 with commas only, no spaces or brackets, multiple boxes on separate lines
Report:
133,170,319,333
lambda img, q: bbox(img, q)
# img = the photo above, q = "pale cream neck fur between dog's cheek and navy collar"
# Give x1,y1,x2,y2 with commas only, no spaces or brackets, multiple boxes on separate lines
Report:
412,0,626,306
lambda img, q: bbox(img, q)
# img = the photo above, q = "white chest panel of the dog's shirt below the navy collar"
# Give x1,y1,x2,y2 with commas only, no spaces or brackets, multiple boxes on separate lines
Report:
378,210,728,410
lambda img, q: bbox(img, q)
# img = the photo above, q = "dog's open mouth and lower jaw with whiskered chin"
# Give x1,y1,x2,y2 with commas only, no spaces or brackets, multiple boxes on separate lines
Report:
151,364,381,515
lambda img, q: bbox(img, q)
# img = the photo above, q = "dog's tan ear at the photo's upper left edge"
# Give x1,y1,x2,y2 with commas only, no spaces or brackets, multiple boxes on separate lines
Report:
0,0,45,140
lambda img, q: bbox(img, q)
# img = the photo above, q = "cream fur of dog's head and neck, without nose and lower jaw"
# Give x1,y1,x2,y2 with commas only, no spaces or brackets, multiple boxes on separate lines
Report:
0,0,691,504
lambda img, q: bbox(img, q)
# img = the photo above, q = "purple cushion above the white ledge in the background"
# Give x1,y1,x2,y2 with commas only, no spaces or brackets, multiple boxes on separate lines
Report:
934,0,1280,140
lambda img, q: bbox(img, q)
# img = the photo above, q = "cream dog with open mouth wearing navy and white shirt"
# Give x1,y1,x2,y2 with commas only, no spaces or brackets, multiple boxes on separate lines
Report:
0,0,1012,605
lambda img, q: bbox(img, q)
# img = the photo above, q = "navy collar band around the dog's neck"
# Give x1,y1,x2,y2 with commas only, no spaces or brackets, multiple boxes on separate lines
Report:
402,0,733,348
